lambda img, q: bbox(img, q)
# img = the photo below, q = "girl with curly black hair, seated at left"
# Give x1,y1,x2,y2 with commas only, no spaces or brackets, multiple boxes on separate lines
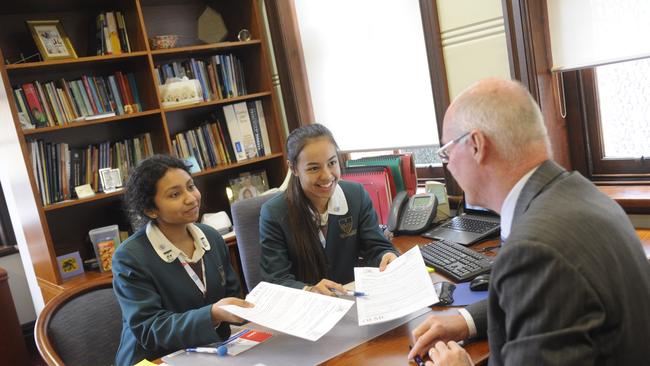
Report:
113,155,252,365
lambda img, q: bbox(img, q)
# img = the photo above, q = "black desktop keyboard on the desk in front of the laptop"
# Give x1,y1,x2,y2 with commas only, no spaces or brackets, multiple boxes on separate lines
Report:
420,240,494,282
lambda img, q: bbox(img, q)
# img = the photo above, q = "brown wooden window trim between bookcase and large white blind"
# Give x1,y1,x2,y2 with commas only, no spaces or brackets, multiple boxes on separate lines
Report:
264,0,315,131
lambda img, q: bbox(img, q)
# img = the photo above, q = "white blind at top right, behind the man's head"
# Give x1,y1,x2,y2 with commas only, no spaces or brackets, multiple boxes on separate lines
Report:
546,0,650,71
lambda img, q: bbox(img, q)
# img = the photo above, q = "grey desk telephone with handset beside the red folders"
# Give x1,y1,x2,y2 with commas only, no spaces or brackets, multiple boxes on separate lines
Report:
388,191,438,234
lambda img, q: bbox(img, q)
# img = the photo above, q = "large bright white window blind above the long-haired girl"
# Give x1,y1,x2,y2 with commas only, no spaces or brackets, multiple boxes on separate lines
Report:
295,0,438,151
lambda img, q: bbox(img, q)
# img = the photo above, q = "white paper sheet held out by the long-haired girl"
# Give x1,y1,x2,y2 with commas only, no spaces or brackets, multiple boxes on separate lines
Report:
354,246,439,325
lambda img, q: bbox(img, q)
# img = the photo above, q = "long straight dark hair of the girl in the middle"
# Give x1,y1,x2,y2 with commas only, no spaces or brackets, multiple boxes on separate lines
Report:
287,123,338,284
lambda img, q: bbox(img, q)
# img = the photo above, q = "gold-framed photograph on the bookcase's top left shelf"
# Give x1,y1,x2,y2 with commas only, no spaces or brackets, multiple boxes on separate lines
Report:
27,20,77,60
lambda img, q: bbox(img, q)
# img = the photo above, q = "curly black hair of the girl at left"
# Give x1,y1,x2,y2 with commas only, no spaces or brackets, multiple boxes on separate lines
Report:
124,154,190,230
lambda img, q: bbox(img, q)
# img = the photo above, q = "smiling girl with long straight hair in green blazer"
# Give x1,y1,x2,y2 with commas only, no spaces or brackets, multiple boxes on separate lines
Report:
260,124,397,296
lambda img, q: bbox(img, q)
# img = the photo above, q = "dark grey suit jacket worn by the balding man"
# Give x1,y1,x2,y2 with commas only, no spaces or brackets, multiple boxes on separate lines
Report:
467,161,650,366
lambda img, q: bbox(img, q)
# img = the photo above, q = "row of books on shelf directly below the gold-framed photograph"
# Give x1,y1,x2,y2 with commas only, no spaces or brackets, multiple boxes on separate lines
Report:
13,71,142,128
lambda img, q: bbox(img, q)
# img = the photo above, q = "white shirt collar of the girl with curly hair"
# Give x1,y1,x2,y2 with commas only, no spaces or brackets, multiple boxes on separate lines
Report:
146,221,210,263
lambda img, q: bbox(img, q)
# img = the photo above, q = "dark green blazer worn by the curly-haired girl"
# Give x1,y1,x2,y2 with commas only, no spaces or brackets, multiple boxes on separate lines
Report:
113,224,240,366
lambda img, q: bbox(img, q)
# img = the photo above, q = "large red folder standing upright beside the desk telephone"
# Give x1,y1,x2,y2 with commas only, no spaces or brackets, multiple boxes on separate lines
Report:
341,166,393,225
